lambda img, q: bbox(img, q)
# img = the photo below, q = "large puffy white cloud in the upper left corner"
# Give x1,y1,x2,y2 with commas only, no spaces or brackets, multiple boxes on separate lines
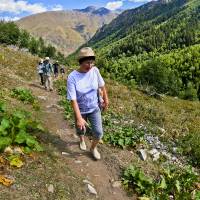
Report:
0,0,47,14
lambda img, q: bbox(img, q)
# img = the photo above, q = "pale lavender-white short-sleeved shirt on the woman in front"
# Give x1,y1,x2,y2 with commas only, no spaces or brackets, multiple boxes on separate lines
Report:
67,67,105,114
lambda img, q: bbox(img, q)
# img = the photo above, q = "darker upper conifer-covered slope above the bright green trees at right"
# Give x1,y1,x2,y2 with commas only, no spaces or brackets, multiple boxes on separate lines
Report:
89,0,200,54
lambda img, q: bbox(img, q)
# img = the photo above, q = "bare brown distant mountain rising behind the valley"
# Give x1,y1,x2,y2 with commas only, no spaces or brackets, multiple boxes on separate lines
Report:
16,8,117,55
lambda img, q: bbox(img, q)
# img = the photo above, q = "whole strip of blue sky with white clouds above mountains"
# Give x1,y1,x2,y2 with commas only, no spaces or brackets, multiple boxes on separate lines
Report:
0,0,152,20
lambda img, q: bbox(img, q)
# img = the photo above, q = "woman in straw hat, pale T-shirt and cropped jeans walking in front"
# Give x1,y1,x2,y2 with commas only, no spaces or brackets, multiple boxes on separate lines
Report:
67,47,108,160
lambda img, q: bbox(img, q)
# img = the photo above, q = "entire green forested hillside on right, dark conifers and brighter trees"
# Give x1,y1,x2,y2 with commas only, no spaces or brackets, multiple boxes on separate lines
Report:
69,0,200,100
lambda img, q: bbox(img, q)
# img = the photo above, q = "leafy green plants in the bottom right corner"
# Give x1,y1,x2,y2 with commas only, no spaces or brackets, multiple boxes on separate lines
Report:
122,165,200,200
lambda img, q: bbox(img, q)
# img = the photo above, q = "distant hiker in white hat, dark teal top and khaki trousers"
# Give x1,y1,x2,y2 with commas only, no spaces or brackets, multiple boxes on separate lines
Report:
43,57,53,91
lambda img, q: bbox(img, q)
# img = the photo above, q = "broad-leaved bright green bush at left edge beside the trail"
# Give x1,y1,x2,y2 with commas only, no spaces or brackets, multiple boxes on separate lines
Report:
0,102,43,152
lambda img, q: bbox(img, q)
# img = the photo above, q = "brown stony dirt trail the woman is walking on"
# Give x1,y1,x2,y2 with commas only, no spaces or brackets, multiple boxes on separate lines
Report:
29,83,134,200
